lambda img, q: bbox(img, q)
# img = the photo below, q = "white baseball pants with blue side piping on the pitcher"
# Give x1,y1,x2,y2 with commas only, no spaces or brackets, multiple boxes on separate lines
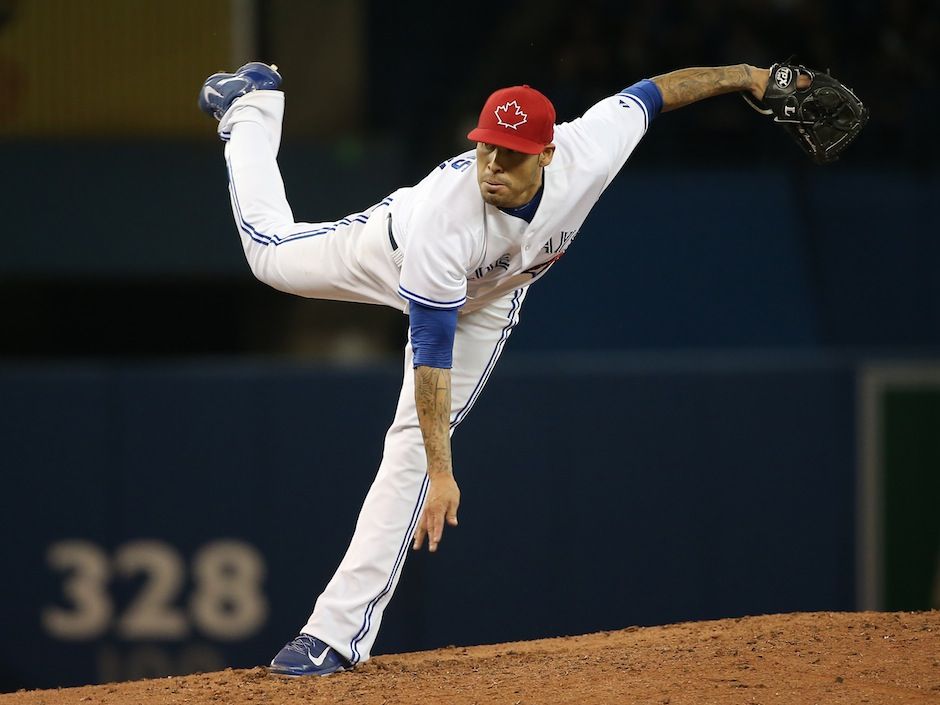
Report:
219,91,526,663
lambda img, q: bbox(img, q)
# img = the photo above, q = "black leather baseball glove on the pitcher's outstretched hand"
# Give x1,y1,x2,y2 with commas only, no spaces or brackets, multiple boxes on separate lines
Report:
741,61,868,164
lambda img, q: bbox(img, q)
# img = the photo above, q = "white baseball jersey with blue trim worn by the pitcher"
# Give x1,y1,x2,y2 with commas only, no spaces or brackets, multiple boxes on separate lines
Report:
389,93,649,313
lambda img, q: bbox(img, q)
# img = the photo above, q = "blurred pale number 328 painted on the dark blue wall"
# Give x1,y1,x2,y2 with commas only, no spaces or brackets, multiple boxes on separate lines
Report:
42,540,268,641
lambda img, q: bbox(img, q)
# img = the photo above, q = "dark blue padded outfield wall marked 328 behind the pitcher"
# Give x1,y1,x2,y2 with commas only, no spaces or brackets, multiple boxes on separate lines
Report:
0,346,908,689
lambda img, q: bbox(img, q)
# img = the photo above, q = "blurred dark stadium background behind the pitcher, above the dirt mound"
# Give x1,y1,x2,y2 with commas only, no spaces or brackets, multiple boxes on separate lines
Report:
0,0,940,691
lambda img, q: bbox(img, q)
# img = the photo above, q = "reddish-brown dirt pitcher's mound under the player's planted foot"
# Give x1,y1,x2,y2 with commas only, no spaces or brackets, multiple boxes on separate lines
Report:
0,611,940,705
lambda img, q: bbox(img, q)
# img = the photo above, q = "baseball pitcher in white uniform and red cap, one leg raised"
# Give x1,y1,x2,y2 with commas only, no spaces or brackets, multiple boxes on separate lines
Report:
199,62,867,676
